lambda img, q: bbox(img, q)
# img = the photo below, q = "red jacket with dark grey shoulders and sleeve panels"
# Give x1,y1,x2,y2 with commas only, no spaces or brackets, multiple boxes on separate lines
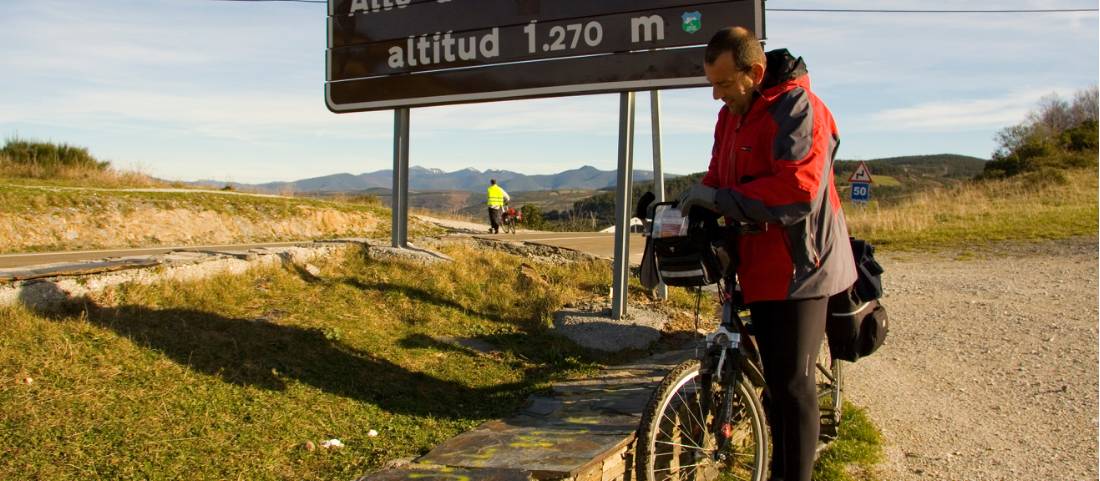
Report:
703,48,856,303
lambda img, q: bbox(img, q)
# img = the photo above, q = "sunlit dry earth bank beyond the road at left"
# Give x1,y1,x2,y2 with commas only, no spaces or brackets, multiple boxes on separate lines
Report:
0,205,388,252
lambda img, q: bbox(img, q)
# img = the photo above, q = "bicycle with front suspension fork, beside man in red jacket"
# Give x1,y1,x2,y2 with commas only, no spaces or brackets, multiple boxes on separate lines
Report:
635,199,843,481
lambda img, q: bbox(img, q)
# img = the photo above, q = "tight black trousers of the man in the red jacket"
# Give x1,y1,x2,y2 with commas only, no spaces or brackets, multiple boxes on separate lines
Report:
749,297,828,481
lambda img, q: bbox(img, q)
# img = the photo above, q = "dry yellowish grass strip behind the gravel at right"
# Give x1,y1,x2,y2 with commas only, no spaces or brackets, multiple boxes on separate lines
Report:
845,170,1098,250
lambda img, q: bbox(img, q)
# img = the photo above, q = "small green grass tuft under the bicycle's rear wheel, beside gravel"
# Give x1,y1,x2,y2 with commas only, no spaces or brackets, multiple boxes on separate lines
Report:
813,402,882,481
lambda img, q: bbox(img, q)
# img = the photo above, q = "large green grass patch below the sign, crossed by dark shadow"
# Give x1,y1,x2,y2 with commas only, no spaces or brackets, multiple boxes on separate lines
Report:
0,245,638,480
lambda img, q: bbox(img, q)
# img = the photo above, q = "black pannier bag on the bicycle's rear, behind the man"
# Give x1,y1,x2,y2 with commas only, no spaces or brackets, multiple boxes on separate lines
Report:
825,238,890,362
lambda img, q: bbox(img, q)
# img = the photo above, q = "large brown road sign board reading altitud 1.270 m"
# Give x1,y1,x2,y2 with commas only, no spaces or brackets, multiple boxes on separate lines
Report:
325,0,765,112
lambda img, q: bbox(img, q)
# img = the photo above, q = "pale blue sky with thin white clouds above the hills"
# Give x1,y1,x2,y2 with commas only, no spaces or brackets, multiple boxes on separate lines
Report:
0,0,1100,183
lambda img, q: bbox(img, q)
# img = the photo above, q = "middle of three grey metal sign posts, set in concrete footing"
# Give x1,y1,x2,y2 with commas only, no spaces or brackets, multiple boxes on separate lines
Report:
612,91,635,320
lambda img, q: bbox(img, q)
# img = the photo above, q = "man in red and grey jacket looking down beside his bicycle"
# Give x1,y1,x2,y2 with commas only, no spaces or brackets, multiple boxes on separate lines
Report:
681,28,856,481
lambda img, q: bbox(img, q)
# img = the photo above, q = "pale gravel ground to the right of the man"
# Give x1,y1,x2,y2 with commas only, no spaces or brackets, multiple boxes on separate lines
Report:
846,239,1098,481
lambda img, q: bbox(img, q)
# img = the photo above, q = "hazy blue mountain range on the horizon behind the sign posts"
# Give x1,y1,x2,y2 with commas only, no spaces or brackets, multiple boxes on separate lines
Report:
195,165,674,194
